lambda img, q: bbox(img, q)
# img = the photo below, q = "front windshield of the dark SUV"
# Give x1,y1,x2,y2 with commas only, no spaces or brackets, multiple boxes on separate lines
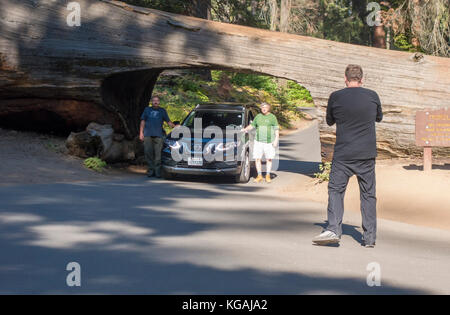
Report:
183,110,242,129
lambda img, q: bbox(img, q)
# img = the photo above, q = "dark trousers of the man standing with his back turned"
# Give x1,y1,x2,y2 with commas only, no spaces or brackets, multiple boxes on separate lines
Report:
326,159,377,244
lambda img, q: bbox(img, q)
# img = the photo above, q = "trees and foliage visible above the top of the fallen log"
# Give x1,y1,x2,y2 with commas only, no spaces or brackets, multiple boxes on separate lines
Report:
124,0,450,56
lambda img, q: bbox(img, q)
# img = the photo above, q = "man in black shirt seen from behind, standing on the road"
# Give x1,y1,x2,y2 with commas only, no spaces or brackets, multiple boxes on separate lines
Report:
313,65,383,247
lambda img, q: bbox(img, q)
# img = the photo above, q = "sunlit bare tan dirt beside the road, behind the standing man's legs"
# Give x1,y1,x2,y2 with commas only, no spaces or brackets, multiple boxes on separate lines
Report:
280,159,450,230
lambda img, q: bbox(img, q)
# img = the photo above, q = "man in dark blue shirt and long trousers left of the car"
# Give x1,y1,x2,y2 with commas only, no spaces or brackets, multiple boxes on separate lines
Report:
139,96,175,177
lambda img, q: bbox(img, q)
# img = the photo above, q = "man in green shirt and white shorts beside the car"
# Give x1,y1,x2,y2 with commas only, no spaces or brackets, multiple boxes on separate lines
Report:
242,103,280,183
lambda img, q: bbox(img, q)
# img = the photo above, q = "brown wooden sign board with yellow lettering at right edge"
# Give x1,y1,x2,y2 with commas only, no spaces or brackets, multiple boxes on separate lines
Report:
416,108,450,147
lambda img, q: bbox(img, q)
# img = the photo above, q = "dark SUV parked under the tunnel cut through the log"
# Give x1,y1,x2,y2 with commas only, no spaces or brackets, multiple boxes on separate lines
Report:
162,103,259,183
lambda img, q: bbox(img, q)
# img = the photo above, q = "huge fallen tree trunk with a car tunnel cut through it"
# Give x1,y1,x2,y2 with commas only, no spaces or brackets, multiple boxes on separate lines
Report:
0,0,450,156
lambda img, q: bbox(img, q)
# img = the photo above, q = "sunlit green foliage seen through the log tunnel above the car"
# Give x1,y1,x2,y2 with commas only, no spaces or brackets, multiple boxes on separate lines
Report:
154,70,314,132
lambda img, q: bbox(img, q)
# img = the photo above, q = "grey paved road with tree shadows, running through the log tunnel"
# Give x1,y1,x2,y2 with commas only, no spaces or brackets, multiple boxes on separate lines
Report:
0,126,450,294
